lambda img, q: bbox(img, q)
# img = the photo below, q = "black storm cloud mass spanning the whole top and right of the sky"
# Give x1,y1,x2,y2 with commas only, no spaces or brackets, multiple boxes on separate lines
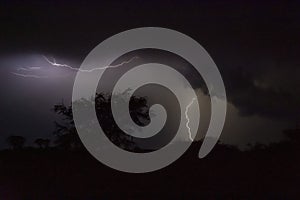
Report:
1,1,300,122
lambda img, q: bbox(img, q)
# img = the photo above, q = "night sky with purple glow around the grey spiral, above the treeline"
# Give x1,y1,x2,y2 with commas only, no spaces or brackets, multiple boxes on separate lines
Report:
0,0,300,148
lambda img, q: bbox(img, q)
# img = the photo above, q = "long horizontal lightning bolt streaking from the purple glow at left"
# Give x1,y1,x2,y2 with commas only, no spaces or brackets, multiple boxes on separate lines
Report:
43,56,138,72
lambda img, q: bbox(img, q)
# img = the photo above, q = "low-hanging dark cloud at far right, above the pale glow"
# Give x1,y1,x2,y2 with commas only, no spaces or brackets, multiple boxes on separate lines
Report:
221,63,300,120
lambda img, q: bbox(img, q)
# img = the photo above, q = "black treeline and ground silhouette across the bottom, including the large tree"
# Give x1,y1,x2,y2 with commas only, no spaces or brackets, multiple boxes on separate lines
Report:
0,94,300,200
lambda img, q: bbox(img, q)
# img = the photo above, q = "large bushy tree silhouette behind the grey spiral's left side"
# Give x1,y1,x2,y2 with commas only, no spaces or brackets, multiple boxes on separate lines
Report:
54,91,149,150
